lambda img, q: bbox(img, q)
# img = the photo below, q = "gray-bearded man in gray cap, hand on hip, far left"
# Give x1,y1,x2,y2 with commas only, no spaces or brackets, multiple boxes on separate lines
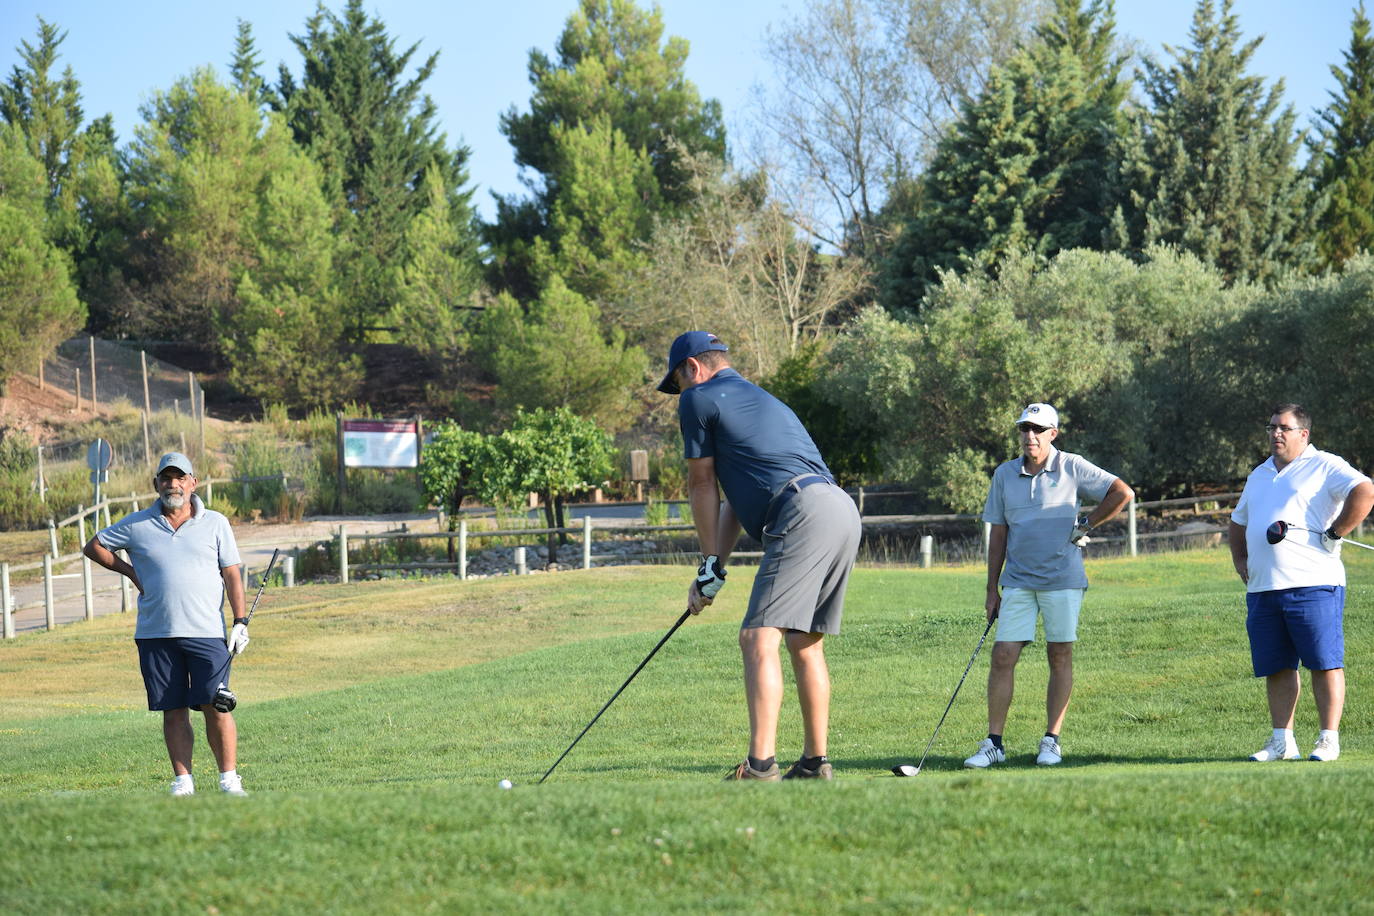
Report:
85,452,249,795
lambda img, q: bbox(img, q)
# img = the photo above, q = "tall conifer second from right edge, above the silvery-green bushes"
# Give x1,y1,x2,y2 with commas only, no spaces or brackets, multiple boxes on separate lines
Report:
1118,0,1316,282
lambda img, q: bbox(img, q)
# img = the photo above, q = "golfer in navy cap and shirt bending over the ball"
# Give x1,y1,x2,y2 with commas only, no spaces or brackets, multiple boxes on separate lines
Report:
658,331,861,780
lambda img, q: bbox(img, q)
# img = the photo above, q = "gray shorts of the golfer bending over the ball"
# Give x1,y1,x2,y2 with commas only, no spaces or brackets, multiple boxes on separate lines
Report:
741,483,863,633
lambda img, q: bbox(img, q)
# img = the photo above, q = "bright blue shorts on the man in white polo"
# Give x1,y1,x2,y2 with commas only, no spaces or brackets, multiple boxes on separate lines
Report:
1245,585,1345,677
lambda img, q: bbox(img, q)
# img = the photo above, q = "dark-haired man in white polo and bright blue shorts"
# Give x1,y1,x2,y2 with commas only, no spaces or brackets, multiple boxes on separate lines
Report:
1228,404,1374,761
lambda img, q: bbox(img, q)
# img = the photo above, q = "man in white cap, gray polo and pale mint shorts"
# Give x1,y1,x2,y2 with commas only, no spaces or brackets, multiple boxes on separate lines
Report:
963,404,1135,769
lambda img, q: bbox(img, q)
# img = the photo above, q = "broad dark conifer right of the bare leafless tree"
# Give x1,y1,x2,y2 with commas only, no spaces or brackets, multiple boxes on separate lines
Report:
882,0,1127,309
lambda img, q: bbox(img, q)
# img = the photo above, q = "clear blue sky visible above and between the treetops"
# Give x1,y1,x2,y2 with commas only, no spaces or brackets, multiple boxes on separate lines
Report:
0,0,1353,217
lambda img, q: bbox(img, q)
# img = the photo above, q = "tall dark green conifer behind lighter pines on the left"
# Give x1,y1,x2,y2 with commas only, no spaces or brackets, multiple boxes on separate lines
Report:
272,0,473,339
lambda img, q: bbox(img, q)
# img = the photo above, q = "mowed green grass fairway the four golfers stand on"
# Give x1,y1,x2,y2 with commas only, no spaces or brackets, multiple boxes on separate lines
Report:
0,549,1374,913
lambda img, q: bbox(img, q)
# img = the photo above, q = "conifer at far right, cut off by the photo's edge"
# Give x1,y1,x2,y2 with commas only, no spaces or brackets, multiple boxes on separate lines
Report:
1312,3,1374,266
